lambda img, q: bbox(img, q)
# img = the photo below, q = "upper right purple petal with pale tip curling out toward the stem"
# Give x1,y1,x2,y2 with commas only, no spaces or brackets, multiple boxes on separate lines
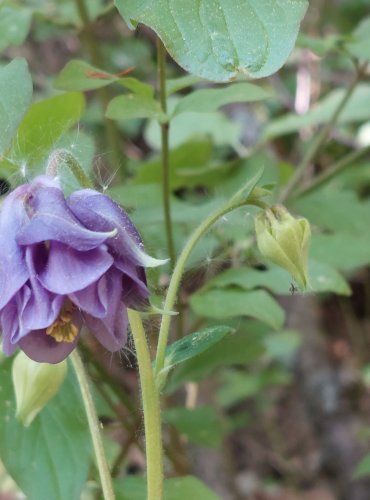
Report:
67,189,163,266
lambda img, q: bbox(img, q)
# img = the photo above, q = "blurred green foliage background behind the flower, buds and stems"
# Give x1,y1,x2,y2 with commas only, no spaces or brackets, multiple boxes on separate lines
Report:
0,0,370,500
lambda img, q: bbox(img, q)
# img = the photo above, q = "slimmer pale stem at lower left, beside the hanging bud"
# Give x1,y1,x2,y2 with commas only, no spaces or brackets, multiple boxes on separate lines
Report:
71,349,115,500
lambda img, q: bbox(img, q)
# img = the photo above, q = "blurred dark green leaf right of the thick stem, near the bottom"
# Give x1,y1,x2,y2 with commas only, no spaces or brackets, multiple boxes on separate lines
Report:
163,406,224,448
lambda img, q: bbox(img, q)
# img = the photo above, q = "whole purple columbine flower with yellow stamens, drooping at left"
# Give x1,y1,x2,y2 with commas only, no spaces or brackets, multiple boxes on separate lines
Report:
0,176,162,363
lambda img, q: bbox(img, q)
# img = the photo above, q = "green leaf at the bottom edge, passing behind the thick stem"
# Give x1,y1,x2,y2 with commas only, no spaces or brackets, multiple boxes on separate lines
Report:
114,476,221,500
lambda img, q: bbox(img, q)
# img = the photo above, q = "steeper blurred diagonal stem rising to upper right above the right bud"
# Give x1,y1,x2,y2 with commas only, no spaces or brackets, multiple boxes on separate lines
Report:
279,71,362,203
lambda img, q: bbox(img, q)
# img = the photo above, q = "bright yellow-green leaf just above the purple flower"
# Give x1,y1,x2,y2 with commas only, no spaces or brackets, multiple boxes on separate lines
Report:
2,92,85,169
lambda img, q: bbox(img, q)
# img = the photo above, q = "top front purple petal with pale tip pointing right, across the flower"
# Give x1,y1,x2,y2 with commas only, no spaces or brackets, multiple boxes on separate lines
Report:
17,184,115,250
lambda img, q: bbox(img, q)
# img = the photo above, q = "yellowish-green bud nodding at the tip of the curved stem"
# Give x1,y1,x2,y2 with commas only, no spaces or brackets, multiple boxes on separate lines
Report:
255,205,311,289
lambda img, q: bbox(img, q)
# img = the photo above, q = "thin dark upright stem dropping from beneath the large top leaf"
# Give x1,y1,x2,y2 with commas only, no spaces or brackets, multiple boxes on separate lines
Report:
157,38,176,268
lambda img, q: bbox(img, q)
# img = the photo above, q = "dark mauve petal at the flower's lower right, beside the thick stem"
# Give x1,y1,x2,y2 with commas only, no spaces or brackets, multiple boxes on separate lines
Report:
83,271,128,352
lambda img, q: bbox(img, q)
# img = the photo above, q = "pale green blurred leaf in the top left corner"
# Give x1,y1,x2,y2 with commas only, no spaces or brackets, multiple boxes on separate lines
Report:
0,5,32,51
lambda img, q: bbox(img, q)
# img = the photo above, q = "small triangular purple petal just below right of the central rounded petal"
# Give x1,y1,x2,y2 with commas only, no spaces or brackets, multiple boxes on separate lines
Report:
69,275,109,318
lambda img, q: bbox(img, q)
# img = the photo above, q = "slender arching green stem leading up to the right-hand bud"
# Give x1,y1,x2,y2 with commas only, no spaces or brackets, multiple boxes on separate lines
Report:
155,199,259,376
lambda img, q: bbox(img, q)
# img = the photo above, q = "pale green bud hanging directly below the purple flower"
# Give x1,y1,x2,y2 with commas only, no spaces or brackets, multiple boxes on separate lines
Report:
12,352,67,427
